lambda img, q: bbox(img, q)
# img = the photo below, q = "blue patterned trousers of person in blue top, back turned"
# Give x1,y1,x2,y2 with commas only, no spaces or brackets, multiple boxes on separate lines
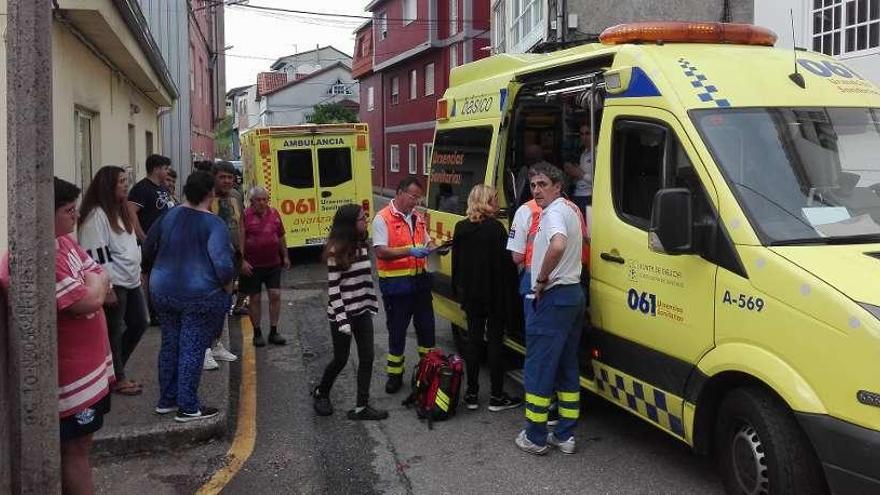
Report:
152,291,230,414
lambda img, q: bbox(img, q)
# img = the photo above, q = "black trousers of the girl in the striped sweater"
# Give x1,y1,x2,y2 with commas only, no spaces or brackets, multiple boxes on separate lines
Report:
318,312,373,407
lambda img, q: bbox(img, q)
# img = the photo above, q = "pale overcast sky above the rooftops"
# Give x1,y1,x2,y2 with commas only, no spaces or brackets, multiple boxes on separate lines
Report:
226,0,368,90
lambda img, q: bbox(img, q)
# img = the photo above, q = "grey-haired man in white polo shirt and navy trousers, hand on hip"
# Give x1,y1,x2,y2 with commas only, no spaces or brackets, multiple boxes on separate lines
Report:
516,165,586,455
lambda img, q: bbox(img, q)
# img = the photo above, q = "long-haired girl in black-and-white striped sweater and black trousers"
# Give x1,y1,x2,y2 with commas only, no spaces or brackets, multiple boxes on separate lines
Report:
312,204,388,420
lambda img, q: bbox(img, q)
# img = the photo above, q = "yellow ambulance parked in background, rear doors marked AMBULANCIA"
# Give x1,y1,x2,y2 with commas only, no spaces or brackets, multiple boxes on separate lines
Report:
241,123,373,248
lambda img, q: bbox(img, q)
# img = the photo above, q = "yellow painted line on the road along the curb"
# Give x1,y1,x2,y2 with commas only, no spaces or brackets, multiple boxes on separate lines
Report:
196,317,257,495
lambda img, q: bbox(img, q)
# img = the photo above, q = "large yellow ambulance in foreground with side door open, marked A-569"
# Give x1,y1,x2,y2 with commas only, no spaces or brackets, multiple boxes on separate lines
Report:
426,22,880,494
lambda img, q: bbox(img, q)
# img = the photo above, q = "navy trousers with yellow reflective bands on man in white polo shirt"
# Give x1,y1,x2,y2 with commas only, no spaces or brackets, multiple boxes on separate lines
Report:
524,284,585,445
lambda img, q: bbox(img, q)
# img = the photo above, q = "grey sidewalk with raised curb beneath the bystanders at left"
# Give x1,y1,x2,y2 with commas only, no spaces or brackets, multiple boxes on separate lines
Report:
93,317,241,457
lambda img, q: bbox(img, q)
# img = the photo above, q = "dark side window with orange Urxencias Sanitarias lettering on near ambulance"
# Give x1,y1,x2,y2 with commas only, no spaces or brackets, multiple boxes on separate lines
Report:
427,126,493,215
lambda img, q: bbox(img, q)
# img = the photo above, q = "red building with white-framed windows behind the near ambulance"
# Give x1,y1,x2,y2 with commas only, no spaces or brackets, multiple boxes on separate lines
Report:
352,0,489,189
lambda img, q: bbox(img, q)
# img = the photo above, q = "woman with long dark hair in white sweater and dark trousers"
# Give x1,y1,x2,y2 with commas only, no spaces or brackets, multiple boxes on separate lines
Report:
78,169,147,395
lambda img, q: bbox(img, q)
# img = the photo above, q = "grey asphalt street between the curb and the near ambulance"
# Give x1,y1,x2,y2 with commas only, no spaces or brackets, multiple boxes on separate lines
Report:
96,251,721,495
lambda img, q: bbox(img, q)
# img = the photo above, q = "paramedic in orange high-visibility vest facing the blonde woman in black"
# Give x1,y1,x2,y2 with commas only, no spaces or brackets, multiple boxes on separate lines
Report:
373,177,434,394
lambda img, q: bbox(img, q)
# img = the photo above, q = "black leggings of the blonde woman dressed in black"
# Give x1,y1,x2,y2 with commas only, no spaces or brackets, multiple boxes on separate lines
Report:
464,314,504,397
